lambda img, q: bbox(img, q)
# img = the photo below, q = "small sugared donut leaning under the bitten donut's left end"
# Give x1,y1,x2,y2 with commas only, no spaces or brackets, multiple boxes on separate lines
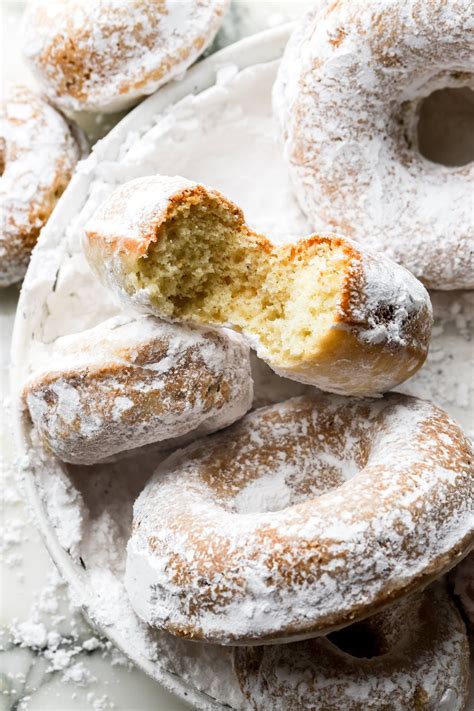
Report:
24,316,253,464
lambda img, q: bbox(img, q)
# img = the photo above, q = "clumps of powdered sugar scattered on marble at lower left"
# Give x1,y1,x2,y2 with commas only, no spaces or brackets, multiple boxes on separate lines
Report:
0,399,129,710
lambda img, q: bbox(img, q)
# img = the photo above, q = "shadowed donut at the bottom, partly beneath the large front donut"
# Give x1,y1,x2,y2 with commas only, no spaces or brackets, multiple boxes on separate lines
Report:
234,587,469,711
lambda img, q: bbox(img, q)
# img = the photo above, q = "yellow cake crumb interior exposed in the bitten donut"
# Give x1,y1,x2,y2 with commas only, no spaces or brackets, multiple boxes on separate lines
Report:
135,196,348,365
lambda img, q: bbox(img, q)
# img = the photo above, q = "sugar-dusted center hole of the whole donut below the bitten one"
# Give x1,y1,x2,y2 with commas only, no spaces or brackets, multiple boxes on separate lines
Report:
201,399,370,515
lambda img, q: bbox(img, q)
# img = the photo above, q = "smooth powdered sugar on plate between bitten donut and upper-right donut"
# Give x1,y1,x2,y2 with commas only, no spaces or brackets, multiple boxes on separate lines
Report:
113,62,310,243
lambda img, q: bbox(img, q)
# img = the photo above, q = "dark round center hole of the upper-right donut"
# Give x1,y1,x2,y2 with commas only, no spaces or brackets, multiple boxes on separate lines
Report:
417,87,474,167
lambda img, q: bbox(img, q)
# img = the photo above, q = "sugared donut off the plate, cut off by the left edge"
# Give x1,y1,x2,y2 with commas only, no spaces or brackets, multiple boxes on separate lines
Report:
0,86,87,287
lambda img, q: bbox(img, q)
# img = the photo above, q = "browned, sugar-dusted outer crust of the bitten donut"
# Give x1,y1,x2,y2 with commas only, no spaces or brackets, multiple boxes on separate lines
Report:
84,175,432,395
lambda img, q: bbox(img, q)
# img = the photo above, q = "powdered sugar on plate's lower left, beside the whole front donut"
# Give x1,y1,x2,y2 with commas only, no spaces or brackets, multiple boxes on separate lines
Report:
21,442,241,708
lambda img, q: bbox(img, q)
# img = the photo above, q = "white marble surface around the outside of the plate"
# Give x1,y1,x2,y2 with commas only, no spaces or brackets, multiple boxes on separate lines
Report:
0,0,311,711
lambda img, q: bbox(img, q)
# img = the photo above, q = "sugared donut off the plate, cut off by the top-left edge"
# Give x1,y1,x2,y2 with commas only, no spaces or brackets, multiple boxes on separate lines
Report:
23,0,228,112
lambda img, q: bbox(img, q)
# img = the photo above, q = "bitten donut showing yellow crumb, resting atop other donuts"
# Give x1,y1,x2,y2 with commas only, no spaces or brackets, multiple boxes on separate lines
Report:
85,176,432,395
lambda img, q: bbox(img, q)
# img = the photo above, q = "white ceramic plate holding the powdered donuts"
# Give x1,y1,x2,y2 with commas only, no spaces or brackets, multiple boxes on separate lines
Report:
12,19,473,708
